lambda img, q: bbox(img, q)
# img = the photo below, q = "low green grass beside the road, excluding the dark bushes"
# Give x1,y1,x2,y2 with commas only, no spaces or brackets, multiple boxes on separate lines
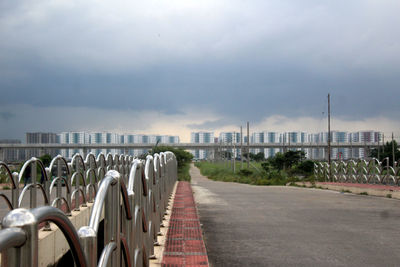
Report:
195,161,293,185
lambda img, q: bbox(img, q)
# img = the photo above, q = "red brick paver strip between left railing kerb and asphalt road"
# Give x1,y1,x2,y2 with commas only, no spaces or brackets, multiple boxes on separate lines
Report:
161,182,208,267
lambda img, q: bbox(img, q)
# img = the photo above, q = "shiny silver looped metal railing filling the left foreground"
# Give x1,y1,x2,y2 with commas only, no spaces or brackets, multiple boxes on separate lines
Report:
0,152,177,266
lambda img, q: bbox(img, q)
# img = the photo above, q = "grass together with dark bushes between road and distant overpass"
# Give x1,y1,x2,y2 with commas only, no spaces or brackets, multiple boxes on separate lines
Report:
195,151,314,185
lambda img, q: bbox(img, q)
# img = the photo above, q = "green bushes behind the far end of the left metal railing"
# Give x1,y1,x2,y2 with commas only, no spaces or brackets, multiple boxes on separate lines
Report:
149,146,193,181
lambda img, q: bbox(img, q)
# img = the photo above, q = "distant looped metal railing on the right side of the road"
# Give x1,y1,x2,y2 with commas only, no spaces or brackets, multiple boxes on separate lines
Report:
314,158,400,186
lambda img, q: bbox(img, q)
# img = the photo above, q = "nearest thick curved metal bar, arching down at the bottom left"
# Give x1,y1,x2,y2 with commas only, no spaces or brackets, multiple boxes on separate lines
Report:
32,206,87,267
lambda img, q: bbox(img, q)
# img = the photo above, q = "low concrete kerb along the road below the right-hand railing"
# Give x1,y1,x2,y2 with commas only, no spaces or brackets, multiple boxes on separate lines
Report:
296,182,400,199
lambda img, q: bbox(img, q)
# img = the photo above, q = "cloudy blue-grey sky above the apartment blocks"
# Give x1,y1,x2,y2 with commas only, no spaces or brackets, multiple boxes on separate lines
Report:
0,0,400,141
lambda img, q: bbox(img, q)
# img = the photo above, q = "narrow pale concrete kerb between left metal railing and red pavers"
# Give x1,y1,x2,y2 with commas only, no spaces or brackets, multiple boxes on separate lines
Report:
150,182,178,267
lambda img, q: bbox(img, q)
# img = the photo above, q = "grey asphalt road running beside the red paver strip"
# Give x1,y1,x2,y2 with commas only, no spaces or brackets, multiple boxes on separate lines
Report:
190,167,400,266
